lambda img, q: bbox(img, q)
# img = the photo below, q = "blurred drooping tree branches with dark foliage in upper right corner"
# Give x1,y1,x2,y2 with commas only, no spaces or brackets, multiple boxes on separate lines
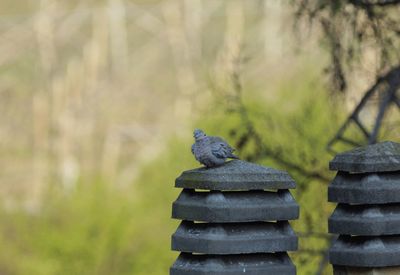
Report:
294,0,400,92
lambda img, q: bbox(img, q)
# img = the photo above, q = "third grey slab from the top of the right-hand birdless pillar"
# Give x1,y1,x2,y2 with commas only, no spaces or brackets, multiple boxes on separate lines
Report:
328,204,400,236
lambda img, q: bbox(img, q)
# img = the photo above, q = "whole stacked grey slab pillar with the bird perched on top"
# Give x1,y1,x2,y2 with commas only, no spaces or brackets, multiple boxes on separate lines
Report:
170,160,299,275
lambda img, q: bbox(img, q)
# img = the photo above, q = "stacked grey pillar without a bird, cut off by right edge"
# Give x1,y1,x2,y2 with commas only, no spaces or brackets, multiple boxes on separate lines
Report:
328,142,400,275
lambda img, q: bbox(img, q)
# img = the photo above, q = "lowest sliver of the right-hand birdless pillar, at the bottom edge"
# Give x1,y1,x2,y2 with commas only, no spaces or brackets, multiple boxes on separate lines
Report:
333,266,400,275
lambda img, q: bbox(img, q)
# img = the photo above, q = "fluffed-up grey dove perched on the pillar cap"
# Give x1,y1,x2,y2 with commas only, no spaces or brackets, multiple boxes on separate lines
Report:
192,129,238,168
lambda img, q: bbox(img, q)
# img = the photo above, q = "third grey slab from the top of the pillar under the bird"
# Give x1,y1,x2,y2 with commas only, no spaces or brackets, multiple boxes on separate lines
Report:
172,221,297,254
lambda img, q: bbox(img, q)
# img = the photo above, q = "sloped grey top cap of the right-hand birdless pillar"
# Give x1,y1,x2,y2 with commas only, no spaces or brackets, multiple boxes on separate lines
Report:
329,141,400,173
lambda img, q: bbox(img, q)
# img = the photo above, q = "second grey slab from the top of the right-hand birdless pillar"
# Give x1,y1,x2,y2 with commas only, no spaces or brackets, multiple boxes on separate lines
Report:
328,172,400,204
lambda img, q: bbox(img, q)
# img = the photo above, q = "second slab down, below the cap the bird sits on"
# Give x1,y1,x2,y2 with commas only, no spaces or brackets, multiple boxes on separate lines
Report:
172,189,299,223
